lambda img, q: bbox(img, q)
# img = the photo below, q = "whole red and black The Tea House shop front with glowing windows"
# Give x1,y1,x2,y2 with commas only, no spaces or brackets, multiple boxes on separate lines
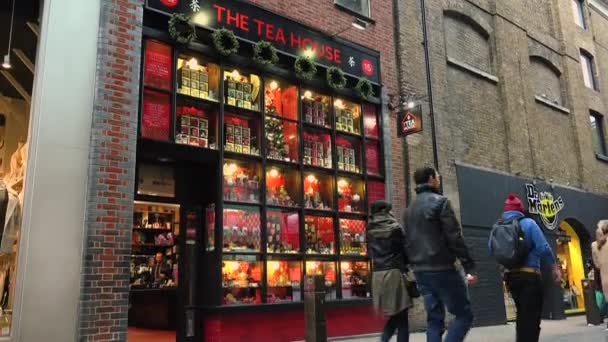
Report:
129,0,385,341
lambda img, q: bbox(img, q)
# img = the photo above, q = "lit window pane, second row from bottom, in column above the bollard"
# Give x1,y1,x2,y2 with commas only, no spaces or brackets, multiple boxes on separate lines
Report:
304,215,336,254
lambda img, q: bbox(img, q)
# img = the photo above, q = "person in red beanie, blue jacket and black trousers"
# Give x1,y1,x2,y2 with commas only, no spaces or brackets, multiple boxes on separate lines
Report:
490,193,561,342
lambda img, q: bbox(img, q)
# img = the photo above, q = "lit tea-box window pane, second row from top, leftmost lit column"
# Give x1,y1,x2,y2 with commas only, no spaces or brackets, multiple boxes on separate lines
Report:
175,98,218,150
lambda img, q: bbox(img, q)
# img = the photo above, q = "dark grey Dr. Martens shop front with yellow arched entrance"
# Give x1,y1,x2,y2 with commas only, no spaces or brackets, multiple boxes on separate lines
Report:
457,164,608,324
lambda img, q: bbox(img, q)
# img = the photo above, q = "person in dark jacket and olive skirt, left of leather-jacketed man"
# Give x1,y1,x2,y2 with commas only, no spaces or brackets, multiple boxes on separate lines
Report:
366,201,412,342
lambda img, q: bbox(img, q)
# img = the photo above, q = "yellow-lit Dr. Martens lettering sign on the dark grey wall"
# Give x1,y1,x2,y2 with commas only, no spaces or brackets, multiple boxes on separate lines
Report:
526,184,564,230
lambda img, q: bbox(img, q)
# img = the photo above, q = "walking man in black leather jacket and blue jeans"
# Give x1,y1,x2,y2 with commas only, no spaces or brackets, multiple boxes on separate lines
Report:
403,167,477,342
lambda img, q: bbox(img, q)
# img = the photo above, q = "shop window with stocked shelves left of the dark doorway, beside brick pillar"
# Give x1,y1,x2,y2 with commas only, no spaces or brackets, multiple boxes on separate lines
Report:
130,202,179,288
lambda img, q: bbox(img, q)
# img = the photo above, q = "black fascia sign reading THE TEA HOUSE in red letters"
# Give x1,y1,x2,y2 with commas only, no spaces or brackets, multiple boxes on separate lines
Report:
147,0,380,83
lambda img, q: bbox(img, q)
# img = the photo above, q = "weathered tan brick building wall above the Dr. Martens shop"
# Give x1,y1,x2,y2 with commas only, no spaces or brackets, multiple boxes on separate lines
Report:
398,0,608,324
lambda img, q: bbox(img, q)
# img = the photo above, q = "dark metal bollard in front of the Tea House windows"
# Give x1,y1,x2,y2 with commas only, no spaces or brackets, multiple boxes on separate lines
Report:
304,275,327,342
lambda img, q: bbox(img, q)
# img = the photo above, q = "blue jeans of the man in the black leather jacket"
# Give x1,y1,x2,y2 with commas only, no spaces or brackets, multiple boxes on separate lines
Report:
415,270,473,342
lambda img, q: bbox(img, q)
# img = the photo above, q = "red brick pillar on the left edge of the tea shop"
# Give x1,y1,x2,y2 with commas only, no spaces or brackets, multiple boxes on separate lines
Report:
78,0,143,341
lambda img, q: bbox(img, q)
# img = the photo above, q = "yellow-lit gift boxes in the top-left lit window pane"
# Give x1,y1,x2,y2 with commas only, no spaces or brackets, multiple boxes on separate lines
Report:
177,57,219,101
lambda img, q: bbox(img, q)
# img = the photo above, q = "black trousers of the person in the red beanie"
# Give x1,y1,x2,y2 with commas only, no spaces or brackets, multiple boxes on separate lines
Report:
507,272,543,342
